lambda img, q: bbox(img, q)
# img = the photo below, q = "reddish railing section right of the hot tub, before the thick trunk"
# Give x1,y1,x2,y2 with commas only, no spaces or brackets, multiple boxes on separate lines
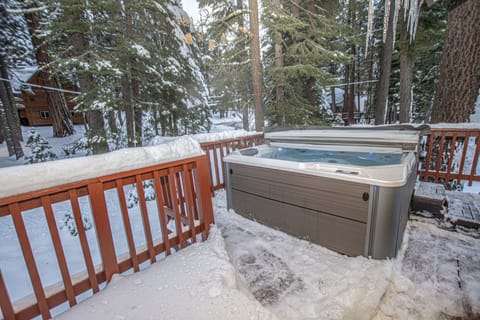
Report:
418,127,480,186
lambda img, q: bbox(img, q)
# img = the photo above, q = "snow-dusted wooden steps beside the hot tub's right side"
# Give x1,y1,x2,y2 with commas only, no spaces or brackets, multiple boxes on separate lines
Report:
412,181,480,229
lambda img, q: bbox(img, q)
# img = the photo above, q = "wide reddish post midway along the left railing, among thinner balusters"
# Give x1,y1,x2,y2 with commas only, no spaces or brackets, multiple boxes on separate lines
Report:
88,182,119,281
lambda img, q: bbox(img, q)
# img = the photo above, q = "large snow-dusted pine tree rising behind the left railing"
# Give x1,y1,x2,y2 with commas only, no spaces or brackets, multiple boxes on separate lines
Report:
46,0,207,149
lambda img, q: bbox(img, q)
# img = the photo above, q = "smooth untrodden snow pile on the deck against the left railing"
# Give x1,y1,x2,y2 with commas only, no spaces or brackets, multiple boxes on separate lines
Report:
58,227,277,320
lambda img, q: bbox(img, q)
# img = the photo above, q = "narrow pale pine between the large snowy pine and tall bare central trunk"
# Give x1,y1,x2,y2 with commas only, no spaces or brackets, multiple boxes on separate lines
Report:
199,0,252,130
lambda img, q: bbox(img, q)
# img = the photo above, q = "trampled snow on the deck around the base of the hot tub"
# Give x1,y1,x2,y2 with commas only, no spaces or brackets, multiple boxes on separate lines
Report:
214,191,480,320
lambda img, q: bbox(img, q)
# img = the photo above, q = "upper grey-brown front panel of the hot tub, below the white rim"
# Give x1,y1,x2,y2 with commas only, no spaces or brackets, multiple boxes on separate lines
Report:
227,163,370,223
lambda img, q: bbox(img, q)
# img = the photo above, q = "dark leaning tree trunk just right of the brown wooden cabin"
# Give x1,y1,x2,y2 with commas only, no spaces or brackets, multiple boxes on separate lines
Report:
25,2,74,137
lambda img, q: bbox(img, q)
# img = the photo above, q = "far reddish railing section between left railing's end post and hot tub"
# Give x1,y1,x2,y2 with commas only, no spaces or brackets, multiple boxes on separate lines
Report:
200,133,264,193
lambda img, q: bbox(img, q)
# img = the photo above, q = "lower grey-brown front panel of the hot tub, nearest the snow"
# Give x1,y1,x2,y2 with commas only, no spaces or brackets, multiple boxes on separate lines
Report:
232,189,366,256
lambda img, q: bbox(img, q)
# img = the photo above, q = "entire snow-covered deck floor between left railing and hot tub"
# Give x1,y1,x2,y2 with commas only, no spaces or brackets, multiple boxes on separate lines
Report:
60,191,480,319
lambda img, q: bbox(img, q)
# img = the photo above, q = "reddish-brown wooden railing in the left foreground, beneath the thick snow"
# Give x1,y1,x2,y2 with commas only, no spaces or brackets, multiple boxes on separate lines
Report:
0,156,213,319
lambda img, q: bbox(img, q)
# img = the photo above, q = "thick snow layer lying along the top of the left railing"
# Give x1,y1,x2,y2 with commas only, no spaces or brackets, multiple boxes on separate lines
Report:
0,136,203,197
